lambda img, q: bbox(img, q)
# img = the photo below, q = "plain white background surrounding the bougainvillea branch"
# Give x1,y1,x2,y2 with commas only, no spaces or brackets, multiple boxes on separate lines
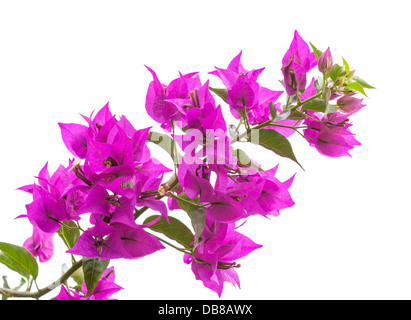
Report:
0,0,411,299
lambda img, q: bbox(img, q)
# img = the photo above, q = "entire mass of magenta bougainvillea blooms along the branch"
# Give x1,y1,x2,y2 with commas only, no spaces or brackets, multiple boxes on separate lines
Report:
15,31,370,299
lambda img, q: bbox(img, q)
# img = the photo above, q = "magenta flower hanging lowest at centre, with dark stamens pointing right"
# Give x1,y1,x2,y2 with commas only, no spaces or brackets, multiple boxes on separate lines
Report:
184,218,262,297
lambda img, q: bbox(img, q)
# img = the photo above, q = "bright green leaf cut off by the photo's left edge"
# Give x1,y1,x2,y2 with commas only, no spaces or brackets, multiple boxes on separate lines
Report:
0,242,39,279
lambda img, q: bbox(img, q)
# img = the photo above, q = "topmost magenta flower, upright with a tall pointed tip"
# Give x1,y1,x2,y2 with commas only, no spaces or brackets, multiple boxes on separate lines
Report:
281,30,317,96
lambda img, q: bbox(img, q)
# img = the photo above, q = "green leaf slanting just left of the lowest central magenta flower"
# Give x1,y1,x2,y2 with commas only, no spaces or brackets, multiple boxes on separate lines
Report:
143,215,194,249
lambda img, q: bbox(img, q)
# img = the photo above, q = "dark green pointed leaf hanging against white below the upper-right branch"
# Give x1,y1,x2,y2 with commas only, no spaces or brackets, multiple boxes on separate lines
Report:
250,129,304,170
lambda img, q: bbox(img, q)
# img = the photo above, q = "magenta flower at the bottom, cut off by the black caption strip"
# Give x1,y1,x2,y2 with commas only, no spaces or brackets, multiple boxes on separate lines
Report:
56,267,123,300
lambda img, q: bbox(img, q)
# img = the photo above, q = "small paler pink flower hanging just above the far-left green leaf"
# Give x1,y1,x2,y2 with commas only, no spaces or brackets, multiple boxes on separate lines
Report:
23,227,54,262
